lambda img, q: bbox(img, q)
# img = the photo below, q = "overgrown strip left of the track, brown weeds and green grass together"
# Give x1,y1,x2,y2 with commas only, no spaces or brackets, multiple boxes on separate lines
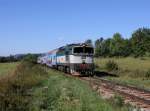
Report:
0,62,131,111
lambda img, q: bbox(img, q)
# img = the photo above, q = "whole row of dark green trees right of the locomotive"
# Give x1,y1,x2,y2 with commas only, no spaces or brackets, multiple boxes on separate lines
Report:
85,28,150,57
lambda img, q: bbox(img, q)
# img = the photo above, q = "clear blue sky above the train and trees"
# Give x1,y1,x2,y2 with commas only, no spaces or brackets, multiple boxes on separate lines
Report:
0,0,150,56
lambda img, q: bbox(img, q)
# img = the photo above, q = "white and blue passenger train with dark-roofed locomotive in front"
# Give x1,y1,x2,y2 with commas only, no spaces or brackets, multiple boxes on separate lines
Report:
37,43,95,76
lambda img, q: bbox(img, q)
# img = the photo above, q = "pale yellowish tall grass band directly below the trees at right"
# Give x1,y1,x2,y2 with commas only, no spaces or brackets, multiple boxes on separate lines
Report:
95,57,150,71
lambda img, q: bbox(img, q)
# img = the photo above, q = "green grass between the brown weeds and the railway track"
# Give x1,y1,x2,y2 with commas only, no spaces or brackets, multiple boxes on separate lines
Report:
32,70,130,111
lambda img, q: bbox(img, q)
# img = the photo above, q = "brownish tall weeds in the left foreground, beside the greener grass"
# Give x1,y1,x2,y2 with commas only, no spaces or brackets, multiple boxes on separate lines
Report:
0,62,47,111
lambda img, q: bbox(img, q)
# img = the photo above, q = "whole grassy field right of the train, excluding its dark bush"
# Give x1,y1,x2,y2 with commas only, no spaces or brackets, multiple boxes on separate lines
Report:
95,57,150,89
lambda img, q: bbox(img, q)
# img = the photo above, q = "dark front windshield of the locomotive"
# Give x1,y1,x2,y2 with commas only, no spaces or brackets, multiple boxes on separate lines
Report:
74,47,94,54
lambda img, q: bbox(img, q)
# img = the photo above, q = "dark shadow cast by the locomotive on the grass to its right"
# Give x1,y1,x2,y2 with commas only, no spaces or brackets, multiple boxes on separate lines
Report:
95,71,119,77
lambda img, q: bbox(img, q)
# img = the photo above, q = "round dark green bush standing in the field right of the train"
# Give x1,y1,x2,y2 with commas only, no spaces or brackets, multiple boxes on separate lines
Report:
106,60,119,71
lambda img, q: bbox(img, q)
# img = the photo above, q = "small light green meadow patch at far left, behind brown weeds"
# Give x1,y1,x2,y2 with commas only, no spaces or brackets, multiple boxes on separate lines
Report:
0,62,18,76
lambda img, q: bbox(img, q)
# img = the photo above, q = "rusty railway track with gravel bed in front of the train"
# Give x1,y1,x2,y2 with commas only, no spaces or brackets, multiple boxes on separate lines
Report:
59,71,150,111
